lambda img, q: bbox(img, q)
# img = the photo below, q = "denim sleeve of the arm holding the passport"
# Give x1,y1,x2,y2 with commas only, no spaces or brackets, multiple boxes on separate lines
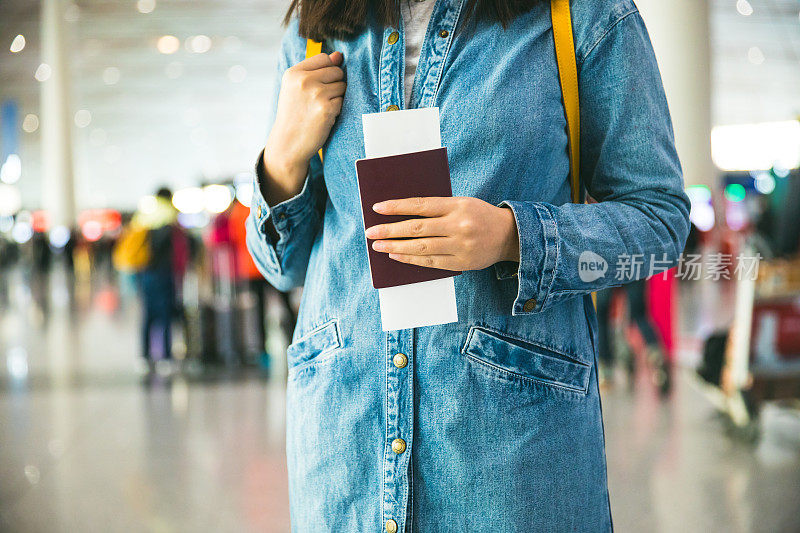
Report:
495,11,689,315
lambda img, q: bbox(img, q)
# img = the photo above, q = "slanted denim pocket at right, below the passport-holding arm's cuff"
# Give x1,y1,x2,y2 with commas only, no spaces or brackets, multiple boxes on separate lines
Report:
461,326,591,394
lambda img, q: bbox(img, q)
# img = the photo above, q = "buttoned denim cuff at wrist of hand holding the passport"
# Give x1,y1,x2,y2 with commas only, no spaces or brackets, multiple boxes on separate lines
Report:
494,201,559,315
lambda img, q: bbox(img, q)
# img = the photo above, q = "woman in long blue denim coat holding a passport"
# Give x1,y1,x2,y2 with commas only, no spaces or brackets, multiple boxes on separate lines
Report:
247,0,688,533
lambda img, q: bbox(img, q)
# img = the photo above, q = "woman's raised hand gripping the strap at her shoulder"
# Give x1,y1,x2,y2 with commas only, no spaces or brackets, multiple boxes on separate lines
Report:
262,52,347,203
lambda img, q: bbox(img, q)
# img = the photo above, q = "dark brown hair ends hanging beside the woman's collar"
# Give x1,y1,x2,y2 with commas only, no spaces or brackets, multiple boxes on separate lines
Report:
283,0,542,41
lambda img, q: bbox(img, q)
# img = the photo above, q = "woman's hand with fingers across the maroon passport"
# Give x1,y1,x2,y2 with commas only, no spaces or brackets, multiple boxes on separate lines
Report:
366,197,519,270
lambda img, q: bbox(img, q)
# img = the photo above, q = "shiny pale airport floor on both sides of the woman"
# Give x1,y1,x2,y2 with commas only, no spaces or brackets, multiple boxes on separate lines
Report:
0,266,800,532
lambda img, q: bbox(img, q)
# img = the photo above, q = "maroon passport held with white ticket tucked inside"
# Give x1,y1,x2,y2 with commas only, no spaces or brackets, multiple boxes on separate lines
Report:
356,148,460,289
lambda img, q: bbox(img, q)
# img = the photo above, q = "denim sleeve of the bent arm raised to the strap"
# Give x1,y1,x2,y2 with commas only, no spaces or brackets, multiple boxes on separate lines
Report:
246,18,327,291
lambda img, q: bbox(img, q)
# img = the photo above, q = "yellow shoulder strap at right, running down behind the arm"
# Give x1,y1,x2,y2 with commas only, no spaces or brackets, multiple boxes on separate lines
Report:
550,0,581,203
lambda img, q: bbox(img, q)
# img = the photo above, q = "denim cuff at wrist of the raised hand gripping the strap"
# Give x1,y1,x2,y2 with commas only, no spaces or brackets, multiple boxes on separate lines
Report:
250,150,316,266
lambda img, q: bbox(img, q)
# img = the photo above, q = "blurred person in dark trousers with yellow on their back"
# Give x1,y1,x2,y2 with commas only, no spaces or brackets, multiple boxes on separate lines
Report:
131,188,178,370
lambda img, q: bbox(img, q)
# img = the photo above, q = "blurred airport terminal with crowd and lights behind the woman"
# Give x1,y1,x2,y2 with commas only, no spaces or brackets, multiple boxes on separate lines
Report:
0,0,800,532
